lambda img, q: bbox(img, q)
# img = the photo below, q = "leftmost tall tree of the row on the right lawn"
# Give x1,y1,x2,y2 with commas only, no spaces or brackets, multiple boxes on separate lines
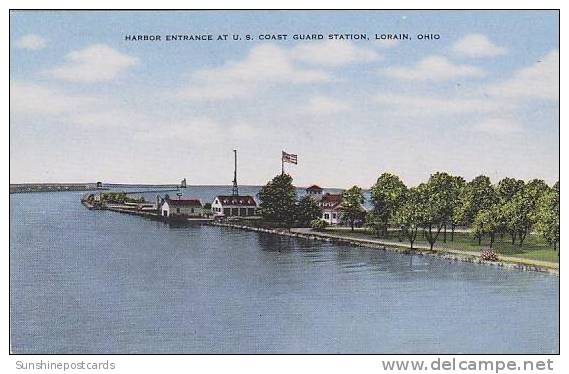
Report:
369,173,407,237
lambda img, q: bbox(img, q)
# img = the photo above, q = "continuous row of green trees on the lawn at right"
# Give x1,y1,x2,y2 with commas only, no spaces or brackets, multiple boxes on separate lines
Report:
367,172,559,249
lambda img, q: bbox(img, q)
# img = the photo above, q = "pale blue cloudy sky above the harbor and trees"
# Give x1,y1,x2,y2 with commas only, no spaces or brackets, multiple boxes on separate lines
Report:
10,11,559,187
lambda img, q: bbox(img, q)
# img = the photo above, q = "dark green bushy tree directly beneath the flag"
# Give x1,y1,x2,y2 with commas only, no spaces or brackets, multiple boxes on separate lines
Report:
258,174,296,228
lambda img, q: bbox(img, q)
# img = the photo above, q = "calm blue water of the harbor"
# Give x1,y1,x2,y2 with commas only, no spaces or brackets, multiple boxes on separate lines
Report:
10,187,559,353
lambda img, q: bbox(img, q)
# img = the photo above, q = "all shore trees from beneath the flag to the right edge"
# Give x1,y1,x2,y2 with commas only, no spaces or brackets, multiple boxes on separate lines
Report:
255,172,559,253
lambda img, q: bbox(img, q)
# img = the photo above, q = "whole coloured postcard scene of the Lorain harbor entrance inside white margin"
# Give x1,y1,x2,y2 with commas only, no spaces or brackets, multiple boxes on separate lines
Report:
9,10,561,358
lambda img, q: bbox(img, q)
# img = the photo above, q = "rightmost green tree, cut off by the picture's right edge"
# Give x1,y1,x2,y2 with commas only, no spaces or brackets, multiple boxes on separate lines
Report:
535,182,559,250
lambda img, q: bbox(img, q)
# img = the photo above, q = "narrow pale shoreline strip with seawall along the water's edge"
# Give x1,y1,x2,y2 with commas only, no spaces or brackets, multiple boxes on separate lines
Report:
209,222,559,276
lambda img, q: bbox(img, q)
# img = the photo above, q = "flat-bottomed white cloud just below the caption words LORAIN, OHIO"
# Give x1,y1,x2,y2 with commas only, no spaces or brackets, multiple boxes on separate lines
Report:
382,56,485,81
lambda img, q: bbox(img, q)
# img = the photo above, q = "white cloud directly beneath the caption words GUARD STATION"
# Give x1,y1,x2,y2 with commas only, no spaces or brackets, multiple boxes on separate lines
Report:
290,40,381,67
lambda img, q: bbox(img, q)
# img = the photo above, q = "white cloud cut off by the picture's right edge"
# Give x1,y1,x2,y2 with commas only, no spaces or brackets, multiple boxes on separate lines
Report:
487,50,559,100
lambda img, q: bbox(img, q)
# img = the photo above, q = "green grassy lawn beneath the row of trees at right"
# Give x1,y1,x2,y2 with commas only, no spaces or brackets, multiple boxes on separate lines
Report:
326,227,559,263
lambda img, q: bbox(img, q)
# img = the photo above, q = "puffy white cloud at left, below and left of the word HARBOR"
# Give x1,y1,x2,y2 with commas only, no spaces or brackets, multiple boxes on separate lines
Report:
48,44,138,83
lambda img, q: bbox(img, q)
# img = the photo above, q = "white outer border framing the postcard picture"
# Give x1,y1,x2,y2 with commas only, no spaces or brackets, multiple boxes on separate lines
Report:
0,0,569,374
